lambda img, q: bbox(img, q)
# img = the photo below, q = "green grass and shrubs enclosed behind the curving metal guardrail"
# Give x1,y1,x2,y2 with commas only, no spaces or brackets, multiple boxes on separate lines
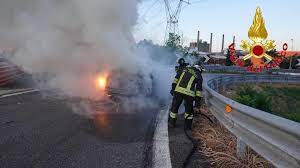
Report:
233,85,300,122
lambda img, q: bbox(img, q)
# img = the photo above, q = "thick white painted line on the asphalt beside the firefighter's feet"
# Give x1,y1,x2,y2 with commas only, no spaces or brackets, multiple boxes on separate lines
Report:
153,110,172,168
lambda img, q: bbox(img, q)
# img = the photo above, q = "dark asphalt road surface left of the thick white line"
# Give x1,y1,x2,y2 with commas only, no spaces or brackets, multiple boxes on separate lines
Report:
0,93,158,168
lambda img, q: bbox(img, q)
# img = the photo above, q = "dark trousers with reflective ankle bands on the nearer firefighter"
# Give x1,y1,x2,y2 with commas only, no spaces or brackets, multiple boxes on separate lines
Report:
169,92,194,129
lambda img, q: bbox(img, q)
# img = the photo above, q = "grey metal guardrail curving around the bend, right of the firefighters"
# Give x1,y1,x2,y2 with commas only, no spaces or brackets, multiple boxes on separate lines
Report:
204,75,300,168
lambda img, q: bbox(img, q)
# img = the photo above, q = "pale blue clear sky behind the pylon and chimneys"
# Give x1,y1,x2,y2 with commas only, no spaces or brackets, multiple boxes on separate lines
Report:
134,0,300,51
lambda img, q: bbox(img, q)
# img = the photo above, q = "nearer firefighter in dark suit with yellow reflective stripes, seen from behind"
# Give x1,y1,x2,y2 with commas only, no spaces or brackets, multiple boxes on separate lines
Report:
168,65,203,130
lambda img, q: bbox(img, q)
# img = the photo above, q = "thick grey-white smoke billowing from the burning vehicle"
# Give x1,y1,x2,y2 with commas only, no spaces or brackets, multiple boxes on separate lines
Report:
0,0,176,114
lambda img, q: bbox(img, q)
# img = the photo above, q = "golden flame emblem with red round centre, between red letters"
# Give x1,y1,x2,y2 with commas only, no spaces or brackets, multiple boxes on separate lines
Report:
241,7,275,64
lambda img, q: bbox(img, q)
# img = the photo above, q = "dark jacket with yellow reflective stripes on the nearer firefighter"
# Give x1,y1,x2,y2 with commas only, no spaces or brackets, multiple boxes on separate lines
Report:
171,67,203,103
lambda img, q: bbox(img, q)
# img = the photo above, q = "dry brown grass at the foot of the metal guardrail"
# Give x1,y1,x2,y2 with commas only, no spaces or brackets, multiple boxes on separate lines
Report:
193,106,273,168
